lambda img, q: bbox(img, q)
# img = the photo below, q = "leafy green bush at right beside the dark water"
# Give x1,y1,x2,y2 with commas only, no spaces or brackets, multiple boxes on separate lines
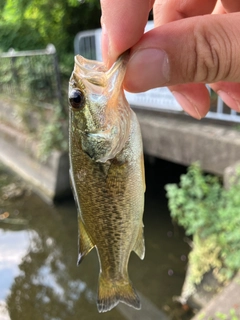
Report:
166,163,240,287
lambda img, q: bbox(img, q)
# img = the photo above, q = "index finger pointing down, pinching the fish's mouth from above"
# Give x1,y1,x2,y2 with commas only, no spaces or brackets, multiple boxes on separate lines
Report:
101,0,154,66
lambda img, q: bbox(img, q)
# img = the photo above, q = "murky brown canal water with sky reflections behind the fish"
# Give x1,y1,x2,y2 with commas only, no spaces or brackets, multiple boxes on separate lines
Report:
0,159,194,320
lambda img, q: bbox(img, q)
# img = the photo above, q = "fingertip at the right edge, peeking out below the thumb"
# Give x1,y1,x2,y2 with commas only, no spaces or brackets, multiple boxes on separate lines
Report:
210,81,240,112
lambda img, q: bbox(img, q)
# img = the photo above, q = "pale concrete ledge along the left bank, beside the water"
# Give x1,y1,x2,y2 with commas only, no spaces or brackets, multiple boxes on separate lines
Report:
0,123,71,202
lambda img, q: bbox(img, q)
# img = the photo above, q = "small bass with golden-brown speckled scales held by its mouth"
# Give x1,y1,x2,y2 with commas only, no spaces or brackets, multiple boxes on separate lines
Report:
69,52,145,313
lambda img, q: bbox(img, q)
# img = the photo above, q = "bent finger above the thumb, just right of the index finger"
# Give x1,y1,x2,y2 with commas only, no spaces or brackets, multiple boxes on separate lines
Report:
153,0,216,26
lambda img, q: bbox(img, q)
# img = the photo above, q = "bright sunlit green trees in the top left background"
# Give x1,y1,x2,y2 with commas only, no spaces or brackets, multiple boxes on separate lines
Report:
0,0,101,77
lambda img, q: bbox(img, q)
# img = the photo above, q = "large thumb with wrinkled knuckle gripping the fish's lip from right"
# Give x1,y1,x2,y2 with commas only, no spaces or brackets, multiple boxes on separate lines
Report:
124,13,240,92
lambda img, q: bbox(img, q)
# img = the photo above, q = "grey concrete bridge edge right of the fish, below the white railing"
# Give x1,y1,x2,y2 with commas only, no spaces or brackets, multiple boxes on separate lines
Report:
134,108,240,175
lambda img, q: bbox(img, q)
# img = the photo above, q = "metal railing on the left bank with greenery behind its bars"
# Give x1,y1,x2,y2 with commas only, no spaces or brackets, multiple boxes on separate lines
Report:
0,44,63,109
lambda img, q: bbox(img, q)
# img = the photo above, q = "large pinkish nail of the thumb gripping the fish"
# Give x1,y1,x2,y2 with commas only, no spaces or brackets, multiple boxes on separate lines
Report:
125,48,170,92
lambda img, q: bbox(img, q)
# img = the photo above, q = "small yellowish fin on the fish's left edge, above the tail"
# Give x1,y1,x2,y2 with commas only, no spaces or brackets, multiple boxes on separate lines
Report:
77,217,95,265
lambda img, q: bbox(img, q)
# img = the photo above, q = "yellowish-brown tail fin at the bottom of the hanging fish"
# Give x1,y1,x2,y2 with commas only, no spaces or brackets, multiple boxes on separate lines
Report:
97,274,141,312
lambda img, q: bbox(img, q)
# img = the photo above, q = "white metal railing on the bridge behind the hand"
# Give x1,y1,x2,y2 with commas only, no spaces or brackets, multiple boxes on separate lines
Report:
74,26,240,123
